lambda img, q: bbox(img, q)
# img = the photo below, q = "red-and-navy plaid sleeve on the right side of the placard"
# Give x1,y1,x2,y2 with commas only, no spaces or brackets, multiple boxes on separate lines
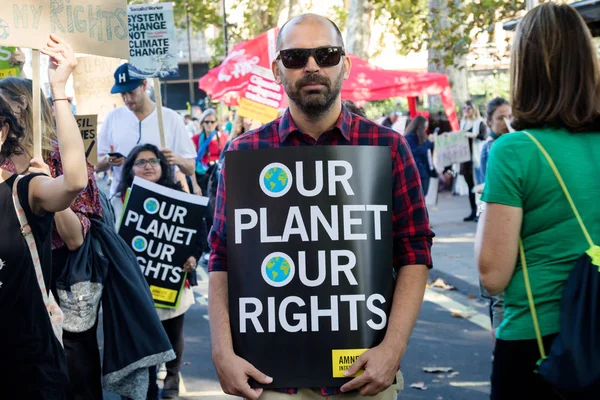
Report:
392,135,434,269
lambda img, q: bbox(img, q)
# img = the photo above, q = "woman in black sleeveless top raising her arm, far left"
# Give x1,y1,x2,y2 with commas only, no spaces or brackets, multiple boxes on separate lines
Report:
0,35,87,399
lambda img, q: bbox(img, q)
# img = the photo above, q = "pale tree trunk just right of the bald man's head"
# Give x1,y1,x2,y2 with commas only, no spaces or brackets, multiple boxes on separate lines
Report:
346,0,373,60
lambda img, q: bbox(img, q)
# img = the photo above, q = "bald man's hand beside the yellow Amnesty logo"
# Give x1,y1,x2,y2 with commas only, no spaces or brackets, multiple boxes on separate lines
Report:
341,343,406,396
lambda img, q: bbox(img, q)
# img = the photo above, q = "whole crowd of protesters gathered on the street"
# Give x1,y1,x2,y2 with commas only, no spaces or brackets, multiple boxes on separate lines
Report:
0,3,600,400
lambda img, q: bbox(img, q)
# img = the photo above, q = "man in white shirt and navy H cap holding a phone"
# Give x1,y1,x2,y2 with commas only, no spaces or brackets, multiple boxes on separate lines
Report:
96,64,196,203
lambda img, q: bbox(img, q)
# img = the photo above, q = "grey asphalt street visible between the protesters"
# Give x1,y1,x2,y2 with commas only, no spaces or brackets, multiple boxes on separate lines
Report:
102,188,492,400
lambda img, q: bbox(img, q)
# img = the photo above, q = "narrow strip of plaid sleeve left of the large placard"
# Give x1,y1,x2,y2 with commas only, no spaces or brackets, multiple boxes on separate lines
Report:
208,152,227,272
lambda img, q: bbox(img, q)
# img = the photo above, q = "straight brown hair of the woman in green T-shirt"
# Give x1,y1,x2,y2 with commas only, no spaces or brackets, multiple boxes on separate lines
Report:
510,2,600,131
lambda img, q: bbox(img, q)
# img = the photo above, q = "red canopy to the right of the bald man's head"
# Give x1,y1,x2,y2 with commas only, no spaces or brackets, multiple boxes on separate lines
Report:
342,54,459,131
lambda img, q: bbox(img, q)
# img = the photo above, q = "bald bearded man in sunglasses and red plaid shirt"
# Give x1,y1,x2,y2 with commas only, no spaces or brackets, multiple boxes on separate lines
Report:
209,14,433,400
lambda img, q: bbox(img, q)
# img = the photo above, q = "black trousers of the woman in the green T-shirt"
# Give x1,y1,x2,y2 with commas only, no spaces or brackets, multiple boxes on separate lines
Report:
491,334,600,400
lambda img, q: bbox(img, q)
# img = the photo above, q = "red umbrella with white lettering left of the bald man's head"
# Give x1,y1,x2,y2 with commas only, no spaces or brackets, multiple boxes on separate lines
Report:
198,28,279,105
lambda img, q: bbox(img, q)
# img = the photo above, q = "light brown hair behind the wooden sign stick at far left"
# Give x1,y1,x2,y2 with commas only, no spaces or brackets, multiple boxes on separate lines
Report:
0,77,57,160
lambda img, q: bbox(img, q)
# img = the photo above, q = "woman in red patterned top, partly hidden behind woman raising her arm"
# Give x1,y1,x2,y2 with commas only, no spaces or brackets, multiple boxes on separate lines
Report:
0,78,102,400
